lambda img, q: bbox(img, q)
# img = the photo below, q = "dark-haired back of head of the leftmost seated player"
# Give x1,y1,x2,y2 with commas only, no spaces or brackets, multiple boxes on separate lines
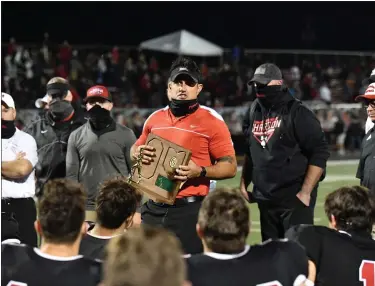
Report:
35,179,86,244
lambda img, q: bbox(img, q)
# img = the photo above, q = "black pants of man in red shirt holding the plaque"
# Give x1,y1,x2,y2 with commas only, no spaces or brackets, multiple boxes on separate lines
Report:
141,200,203,254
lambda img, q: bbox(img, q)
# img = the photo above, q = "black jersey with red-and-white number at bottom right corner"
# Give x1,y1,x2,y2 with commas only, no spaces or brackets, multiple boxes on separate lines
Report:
286,225,375,286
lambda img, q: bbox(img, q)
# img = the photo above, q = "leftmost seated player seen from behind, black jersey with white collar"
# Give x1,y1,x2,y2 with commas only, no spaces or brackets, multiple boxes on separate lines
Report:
1,179,101,286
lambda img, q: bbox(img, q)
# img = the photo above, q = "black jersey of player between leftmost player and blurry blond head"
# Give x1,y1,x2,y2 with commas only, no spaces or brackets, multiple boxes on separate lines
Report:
79,233,110,260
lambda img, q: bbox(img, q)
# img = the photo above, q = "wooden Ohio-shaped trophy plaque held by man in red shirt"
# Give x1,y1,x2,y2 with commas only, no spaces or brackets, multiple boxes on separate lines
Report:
128,133,191,205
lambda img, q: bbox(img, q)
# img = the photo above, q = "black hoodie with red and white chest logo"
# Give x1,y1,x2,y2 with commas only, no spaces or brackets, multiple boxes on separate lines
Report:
243,93,329,201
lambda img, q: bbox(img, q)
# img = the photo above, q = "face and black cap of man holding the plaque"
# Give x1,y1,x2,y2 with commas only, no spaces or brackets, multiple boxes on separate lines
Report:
167,57,203,100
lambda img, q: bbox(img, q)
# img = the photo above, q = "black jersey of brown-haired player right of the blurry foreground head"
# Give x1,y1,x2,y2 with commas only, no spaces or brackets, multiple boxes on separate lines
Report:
187,240,308,286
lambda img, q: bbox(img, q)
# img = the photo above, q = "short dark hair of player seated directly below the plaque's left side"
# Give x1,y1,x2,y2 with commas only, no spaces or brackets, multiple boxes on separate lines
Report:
96,176,142,229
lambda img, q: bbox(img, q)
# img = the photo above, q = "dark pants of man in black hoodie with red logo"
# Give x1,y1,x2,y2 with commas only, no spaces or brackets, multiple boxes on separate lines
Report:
258,187,317,241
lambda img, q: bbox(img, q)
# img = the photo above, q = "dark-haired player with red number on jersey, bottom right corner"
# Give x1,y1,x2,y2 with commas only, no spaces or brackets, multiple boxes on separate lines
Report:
286,186,375,286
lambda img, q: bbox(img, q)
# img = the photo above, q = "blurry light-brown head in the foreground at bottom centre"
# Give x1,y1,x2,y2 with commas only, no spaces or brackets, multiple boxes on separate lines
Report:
103,225,187,286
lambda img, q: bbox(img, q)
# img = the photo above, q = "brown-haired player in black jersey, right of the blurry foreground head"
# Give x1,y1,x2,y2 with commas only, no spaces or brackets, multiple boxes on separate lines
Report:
187,189,315,286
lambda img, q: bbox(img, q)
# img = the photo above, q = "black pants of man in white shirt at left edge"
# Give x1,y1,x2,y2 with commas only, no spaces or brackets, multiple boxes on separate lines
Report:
1,198,38,247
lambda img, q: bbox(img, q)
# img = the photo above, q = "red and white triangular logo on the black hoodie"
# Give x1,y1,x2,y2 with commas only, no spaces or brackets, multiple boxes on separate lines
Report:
252,117,281,148
